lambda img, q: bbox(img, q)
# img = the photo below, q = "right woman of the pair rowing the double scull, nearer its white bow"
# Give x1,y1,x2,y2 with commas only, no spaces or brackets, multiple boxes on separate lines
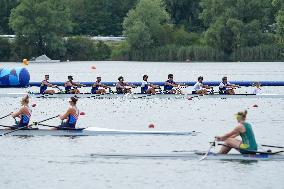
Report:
59,97,79,129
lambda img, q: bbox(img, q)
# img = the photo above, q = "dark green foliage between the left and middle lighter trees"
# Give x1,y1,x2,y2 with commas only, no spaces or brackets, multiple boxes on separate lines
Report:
69,0,137,36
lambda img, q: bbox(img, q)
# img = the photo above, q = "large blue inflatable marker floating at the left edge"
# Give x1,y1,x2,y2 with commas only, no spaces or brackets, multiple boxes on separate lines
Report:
0,68,30,87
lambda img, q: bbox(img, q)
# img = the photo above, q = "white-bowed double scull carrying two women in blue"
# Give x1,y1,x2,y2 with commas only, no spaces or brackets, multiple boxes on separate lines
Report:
0,127,197,136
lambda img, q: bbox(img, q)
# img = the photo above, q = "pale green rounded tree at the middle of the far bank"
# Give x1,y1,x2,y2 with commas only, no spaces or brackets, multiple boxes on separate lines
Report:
123,0,169,49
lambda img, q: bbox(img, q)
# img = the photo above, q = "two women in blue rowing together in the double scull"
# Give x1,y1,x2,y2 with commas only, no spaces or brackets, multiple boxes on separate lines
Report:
3,95,79,129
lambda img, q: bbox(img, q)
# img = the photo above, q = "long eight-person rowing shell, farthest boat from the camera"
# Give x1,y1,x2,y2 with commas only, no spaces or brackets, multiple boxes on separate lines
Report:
0,93,284,99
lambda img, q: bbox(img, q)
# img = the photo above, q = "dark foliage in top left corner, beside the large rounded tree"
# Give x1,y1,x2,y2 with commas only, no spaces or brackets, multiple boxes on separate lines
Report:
0,0,19,34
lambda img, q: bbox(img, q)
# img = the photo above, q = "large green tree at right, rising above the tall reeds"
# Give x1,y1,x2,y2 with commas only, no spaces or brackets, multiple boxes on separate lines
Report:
200,0,273,54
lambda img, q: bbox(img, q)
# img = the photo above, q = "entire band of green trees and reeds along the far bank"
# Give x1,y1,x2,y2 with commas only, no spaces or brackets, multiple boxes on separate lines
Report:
0,0,284,61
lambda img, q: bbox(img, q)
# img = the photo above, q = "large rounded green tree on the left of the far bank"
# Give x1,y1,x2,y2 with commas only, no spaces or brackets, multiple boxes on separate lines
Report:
9,0,72,58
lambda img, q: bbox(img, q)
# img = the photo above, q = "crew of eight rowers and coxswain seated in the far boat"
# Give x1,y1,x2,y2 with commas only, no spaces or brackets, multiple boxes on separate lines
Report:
40,74,261,95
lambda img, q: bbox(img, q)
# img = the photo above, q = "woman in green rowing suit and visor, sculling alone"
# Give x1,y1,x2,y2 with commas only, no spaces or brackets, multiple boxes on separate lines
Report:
215,110,257,154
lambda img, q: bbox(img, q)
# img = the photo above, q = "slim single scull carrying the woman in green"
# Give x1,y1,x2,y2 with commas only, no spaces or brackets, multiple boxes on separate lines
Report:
91,152,284,161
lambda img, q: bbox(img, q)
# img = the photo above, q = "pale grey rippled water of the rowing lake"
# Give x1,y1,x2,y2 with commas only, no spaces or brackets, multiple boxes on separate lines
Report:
0,62,284,189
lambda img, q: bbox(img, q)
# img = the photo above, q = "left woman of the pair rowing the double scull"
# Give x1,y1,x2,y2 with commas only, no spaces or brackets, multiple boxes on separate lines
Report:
11,95,32,128
